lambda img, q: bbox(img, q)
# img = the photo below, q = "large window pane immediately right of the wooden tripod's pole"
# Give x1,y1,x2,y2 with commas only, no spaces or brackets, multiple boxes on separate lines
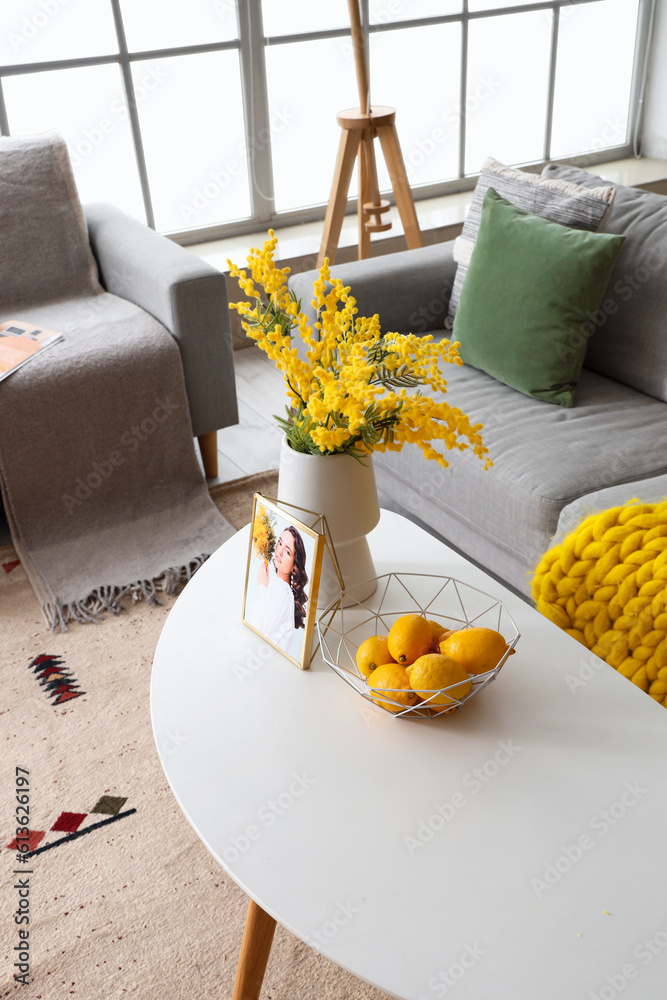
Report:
371,24,461,191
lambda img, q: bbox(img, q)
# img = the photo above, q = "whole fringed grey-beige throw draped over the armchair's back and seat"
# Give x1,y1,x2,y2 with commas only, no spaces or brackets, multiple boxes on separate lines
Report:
0,134,234,629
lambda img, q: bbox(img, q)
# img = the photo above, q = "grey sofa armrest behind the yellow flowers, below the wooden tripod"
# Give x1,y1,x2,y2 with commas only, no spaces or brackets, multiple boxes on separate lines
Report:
289,241,457,334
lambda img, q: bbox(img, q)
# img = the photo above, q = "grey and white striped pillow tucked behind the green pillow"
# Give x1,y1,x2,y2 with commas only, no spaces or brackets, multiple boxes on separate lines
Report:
448,158,614,320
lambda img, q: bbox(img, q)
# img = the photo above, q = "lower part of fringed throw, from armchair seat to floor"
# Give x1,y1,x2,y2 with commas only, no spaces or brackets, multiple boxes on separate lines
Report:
0,293,234,629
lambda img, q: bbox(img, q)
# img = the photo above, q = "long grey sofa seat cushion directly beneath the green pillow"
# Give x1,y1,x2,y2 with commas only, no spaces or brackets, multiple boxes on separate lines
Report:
374,356,667,594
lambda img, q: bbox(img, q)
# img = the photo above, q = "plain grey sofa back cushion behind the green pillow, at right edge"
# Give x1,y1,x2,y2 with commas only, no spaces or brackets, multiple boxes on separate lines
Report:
543,163,667,400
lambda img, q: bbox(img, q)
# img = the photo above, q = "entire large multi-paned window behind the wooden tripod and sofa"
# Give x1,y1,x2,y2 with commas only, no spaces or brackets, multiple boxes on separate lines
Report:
0,0,655,242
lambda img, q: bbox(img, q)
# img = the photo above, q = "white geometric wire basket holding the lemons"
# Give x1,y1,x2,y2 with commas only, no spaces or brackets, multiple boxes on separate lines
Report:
316,573,520,719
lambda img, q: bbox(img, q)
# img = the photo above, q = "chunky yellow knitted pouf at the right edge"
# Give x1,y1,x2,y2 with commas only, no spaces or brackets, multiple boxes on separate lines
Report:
532,500,667,708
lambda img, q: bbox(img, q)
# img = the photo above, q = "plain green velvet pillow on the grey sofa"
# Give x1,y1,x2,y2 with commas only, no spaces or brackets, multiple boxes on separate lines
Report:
453,188,624,406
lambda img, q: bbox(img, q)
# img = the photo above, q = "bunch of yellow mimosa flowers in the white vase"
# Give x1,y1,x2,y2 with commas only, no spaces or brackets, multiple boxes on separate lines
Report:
227,230,492,468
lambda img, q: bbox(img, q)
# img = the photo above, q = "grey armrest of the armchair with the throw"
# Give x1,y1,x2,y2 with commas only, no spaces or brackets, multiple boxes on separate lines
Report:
84,203,238,435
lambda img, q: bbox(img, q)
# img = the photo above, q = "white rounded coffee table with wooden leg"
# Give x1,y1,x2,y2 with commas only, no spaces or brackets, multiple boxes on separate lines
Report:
151,511,667,1000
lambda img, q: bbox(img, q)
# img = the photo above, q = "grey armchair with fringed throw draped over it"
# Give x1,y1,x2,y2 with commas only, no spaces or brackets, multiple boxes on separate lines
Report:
0,133,237,627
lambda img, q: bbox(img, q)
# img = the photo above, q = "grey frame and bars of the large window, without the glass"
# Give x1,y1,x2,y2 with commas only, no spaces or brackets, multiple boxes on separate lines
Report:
0,0,656,245
